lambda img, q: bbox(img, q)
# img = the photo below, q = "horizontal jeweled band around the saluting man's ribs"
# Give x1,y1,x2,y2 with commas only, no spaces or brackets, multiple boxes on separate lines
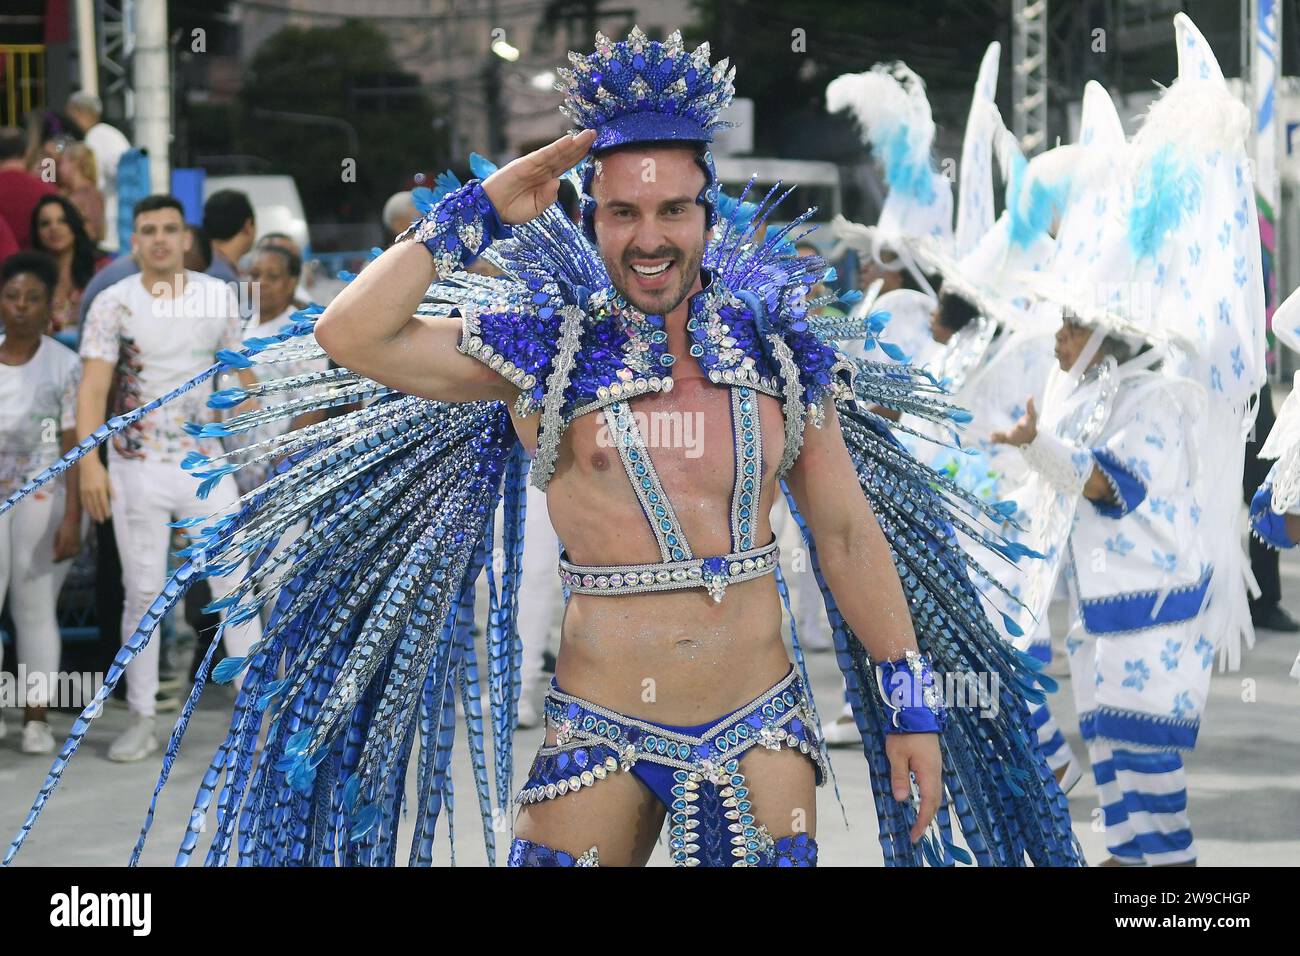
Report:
560,537,781,601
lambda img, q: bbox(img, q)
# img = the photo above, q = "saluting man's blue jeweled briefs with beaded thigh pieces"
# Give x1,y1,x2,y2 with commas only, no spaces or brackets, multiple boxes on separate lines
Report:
511,669,826,866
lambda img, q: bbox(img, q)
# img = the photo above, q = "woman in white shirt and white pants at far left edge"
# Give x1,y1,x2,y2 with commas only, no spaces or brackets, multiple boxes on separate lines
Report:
0,252,82,754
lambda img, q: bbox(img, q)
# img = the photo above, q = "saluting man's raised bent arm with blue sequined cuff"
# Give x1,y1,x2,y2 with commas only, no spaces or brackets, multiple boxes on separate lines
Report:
316,130,594,402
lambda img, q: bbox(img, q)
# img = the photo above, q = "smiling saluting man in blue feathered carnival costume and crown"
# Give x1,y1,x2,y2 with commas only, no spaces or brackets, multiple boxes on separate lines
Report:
0,30,1082,866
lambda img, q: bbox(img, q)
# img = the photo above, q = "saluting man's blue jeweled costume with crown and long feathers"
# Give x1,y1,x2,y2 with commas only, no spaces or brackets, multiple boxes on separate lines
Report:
7,30,1080,865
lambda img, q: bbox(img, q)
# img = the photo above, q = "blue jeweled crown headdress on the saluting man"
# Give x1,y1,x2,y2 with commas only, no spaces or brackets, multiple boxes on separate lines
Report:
555,27,736,152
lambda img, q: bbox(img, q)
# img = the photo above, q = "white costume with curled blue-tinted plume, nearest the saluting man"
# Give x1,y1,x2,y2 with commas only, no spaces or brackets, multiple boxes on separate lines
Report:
827,43,1052,650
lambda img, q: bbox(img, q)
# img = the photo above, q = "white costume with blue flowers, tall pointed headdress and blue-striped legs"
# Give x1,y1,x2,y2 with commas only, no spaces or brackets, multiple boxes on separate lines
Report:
1008,14,1264,865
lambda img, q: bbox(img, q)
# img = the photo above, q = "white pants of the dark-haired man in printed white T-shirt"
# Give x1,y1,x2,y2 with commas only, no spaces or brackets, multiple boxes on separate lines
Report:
108,454,261,717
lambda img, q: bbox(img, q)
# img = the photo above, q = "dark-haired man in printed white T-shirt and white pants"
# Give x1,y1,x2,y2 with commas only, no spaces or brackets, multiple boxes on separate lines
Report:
77,196,261,762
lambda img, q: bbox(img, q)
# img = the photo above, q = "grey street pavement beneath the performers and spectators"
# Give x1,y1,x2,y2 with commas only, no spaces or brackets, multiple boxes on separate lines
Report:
0,553,1300,866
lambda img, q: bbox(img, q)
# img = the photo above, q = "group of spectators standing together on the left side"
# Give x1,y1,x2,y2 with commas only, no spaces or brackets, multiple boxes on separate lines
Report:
0,94,340,761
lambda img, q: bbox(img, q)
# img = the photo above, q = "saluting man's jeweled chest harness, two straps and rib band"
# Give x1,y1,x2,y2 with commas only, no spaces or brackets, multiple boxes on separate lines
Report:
559,304,780,601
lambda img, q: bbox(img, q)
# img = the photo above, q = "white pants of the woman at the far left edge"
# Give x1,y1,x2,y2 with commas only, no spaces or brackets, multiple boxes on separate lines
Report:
0,480,73,708
